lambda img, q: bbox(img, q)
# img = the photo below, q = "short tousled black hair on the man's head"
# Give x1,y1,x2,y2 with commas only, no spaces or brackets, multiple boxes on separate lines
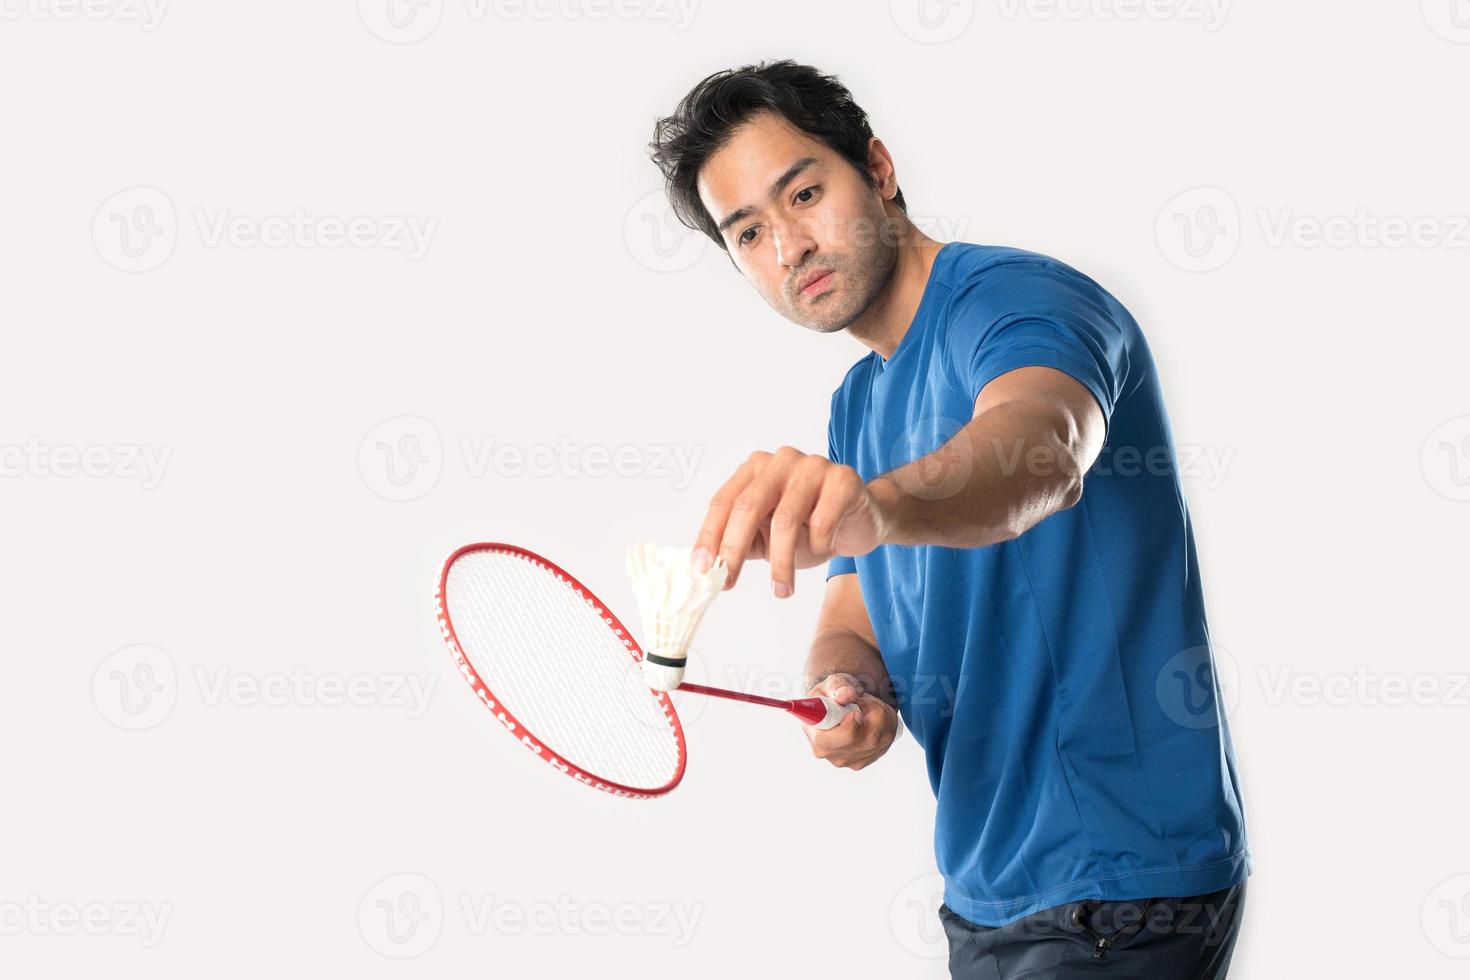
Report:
648,59,907,248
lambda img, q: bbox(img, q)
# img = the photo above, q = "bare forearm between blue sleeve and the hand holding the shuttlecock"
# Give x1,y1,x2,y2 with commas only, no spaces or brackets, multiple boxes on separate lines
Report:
869,400,1095,548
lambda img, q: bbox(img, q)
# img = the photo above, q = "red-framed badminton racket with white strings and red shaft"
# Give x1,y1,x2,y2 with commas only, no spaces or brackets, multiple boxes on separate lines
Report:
435,544,857,799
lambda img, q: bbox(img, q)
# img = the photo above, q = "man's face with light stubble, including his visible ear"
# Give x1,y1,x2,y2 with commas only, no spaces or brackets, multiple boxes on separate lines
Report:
698,113,898,334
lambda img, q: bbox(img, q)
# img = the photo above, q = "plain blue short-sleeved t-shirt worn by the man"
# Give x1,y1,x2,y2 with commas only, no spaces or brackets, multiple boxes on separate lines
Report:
828,242,1250,926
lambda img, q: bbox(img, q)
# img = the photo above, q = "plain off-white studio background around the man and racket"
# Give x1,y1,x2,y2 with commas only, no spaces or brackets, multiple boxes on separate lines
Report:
0,0,1470,979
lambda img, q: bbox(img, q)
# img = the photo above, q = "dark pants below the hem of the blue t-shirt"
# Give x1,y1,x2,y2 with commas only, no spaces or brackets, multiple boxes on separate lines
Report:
939,882,1245,980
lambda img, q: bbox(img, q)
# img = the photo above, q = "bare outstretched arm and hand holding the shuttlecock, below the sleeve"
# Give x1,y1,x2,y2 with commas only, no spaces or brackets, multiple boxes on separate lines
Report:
694,367,1105,597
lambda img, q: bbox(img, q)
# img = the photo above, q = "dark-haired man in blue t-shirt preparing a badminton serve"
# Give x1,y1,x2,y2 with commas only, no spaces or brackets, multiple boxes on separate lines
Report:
651,62,1250,979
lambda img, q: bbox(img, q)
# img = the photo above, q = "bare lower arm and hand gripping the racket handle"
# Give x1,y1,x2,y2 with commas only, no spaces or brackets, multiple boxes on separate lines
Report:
806,573,898,771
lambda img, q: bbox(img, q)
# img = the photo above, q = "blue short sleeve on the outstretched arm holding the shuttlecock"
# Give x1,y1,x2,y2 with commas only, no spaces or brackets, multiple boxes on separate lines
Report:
947,264,1127,423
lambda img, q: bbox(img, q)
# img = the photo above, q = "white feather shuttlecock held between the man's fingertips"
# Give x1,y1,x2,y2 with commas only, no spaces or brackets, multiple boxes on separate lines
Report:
628,545,729,691
